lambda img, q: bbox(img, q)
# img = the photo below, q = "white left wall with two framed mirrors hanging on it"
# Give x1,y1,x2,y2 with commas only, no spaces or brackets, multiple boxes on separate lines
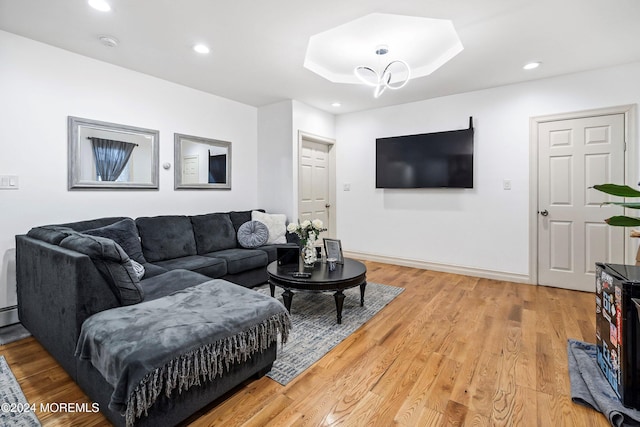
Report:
0,31,258,308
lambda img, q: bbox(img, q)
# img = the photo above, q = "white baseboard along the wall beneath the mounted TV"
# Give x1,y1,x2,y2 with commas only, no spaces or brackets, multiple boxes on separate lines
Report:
344,251,533,284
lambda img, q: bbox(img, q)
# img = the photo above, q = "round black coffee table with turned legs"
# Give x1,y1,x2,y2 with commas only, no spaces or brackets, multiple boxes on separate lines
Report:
267,258,367,323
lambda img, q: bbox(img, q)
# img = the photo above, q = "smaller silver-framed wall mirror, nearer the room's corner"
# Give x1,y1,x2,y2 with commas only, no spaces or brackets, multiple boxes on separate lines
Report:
174,133,231,190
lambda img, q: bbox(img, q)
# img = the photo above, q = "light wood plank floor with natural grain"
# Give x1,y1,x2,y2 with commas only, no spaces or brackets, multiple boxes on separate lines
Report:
0,262,609,427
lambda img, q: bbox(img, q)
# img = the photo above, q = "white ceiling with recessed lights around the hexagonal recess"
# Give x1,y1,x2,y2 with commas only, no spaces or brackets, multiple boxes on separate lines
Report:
0,0,640,114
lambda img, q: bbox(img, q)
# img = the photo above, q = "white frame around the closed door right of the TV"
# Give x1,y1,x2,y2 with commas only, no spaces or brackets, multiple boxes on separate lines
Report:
529,104,639,285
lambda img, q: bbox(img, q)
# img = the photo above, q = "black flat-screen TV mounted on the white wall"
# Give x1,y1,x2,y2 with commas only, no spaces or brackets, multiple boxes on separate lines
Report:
376,117,473,188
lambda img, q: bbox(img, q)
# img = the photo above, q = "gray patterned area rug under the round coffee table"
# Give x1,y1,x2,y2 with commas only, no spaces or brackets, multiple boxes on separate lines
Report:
256,282,404,385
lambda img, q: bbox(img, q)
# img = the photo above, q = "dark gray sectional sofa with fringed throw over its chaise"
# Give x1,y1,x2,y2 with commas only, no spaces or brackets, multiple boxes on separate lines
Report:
16,211,296,426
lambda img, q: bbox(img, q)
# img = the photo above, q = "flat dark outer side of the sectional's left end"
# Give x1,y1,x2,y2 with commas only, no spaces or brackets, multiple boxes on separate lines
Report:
16,235,120,380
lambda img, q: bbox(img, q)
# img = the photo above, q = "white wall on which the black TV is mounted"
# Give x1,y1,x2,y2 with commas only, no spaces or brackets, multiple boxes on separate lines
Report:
336,63,640,279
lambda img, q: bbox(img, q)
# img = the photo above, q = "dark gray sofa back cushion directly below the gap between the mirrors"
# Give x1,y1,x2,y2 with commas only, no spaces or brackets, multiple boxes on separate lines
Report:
136,215,197,263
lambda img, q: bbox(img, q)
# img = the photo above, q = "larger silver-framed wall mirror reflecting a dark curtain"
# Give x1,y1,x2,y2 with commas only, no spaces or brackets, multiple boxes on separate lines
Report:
68,116,159,190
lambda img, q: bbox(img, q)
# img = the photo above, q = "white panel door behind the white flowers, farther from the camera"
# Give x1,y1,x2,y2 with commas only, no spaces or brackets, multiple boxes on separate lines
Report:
298,139,331,238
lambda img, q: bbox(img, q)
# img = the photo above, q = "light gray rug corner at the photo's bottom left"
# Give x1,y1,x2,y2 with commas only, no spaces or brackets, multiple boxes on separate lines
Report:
0,356,40,427
